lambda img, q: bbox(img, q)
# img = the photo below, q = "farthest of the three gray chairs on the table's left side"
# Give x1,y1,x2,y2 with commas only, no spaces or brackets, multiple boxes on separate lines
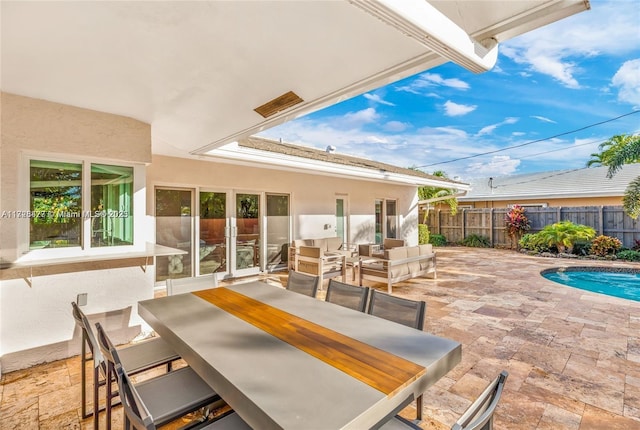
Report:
71,302,180,430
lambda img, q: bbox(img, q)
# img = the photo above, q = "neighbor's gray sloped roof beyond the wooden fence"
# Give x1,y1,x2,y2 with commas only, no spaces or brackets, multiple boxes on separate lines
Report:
458,164,640,202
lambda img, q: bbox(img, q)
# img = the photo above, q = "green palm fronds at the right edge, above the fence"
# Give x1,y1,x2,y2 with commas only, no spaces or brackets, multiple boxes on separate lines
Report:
587,134,640,219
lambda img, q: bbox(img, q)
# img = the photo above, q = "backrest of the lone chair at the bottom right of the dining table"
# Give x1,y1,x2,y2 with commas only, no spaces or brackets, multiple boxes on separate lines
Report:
451,370,509,430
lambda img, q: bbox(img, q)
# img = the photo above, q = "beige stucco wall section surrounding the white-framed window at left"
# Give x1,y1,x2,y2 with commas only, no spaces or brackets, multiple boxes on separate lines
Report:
0,93,154,372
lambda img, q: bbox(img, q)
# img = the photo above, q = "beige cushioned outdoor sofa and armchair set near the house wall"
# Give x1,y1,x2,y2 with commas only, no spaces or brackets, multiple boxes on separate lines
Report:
289,237,436,294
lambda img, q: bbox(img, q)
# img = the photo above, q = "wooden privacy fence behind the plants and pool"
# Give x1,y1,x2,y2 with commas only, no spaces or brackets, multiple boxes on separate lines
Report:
419,206,640,248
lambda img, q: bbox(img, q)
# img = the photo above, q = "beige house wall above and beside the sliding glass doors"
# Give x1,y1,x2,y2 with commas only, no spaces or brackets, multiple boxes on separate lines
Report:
147,155,418,245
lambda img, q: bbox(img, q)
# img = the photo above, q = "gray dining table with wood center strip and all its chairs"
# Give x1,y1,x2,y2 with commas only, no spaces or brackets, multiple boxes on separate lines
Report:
72,272,507,430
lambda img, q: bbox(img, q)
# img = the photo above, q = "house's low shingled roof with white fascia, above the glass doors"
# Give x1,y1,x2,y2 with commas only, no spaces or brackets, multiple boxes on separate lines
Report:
209,136,468,190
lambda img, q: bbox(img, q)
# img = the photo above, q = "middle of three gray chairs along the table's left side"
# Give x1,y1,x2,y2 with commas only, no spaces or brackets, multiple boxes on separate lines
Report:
96,323,221,430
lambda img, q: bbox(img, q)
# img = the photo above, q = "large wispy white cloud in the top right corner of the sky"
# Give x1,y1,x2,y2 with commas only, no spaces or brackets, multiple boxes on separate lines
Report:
501,1,638,88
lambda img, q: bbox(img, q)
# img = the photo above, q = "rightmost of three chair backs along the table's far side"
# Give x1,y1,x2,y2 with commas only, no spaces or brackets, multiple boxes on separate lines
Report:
367,289,427,330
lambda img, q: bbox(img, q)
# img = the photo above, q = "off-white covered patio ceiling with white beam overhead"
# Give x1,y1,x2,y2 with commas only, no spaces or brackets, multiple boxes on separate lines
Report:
0,0,589,157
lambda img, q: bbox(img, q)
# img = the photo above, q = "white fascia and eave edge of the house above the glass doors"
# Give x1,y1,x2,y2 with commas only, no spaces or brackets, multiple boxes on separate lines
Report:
206,142,470,191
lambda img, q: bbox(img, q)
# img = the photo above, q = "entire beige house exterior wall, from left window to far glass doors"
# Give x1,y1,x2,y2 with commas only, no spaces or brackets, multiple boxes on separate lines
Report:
0,93,424,373
